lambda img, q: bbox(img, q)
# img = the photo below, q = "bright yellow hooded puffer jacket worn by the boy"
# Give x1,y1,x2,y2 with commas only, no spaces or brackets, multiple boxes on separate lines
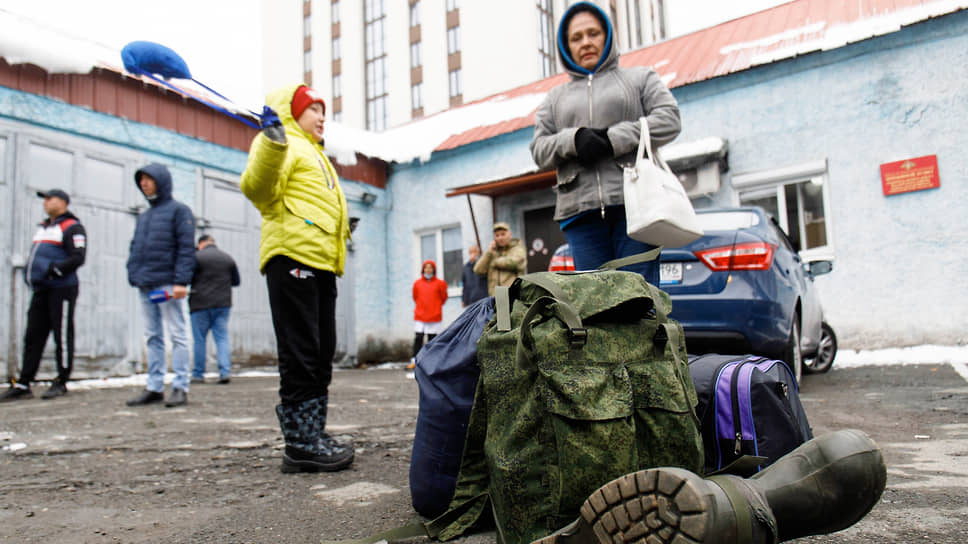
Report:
242,85,350,276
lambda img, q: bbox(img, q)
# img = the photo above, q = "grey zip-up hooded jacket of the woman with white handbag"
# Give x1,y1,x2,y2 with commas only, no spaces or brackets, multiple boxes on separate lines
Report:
530,2,681,221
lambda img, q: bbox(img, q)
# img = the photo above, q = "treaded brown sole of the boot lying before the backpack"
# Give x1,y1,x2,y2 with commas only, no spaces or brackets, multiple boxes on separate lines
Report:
535,468,715,544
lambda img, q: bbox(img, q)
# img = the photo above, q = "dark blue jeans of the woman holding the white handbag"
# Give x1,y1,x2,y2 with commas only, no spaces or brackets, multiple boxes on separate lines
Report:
562,206,659,287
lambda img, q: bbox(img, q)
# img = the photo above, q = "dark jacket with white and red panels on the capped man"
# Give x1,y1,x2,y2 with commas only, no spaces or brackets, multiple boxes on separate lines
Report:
24,212,87,290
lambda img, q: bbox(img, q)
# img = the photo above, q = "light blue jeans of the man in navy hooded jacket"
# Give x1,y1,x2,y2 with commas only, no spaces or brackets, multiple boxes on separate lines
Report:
139,285,188,393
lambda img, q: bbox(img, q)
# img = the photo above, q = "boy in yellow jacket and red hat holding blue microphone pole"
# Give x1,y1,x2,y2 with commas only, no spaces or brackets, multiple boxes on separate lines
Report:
242,85,354,472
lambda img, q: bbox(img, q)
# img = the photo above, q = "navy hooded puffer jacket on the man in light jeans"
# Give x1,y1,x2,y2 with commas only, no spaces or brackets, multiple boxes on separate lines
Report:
128,164,195,289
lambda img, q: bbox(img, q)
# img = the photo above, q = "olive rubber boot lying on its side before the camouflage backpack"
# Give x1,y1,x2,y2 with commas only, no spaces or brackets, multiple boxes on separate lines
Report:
537,430,887,544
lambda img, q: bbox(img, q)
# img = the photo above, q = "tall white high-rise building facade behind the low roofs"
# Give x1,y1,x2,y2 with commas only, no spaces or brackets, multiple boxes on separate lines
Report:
262,0,665,131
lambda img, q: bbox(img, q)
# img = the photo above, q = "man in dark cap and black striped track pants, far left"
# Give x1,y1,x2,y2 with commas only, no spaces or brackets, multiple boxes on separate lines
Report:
0,189,87,402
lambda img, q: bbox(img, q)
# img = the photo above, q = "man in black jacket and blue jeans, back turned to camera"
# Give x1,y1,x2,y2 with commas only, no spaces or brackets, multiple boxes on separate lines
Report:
188,234,240,384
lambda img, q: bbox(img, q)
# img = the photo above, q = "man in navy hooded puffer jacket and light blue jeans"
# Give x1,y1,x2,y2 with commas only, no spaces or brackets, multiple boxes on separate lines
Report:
127,164,195,407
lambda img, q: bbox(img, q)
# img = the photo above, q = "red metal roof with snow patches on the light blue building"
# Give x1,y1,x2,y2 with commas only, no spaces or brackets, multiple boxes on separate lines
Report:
434,0,968,151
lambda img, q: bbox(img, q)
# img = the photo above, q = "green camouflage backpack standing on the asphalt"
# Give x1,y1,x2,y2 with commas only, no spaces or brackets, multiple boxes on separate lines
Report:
427,251,703,544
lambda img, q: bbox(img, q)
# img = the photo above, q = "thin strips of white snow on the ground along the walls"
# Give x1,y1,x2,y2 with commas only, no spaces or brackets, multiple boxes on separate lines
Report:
71,345,968,390
